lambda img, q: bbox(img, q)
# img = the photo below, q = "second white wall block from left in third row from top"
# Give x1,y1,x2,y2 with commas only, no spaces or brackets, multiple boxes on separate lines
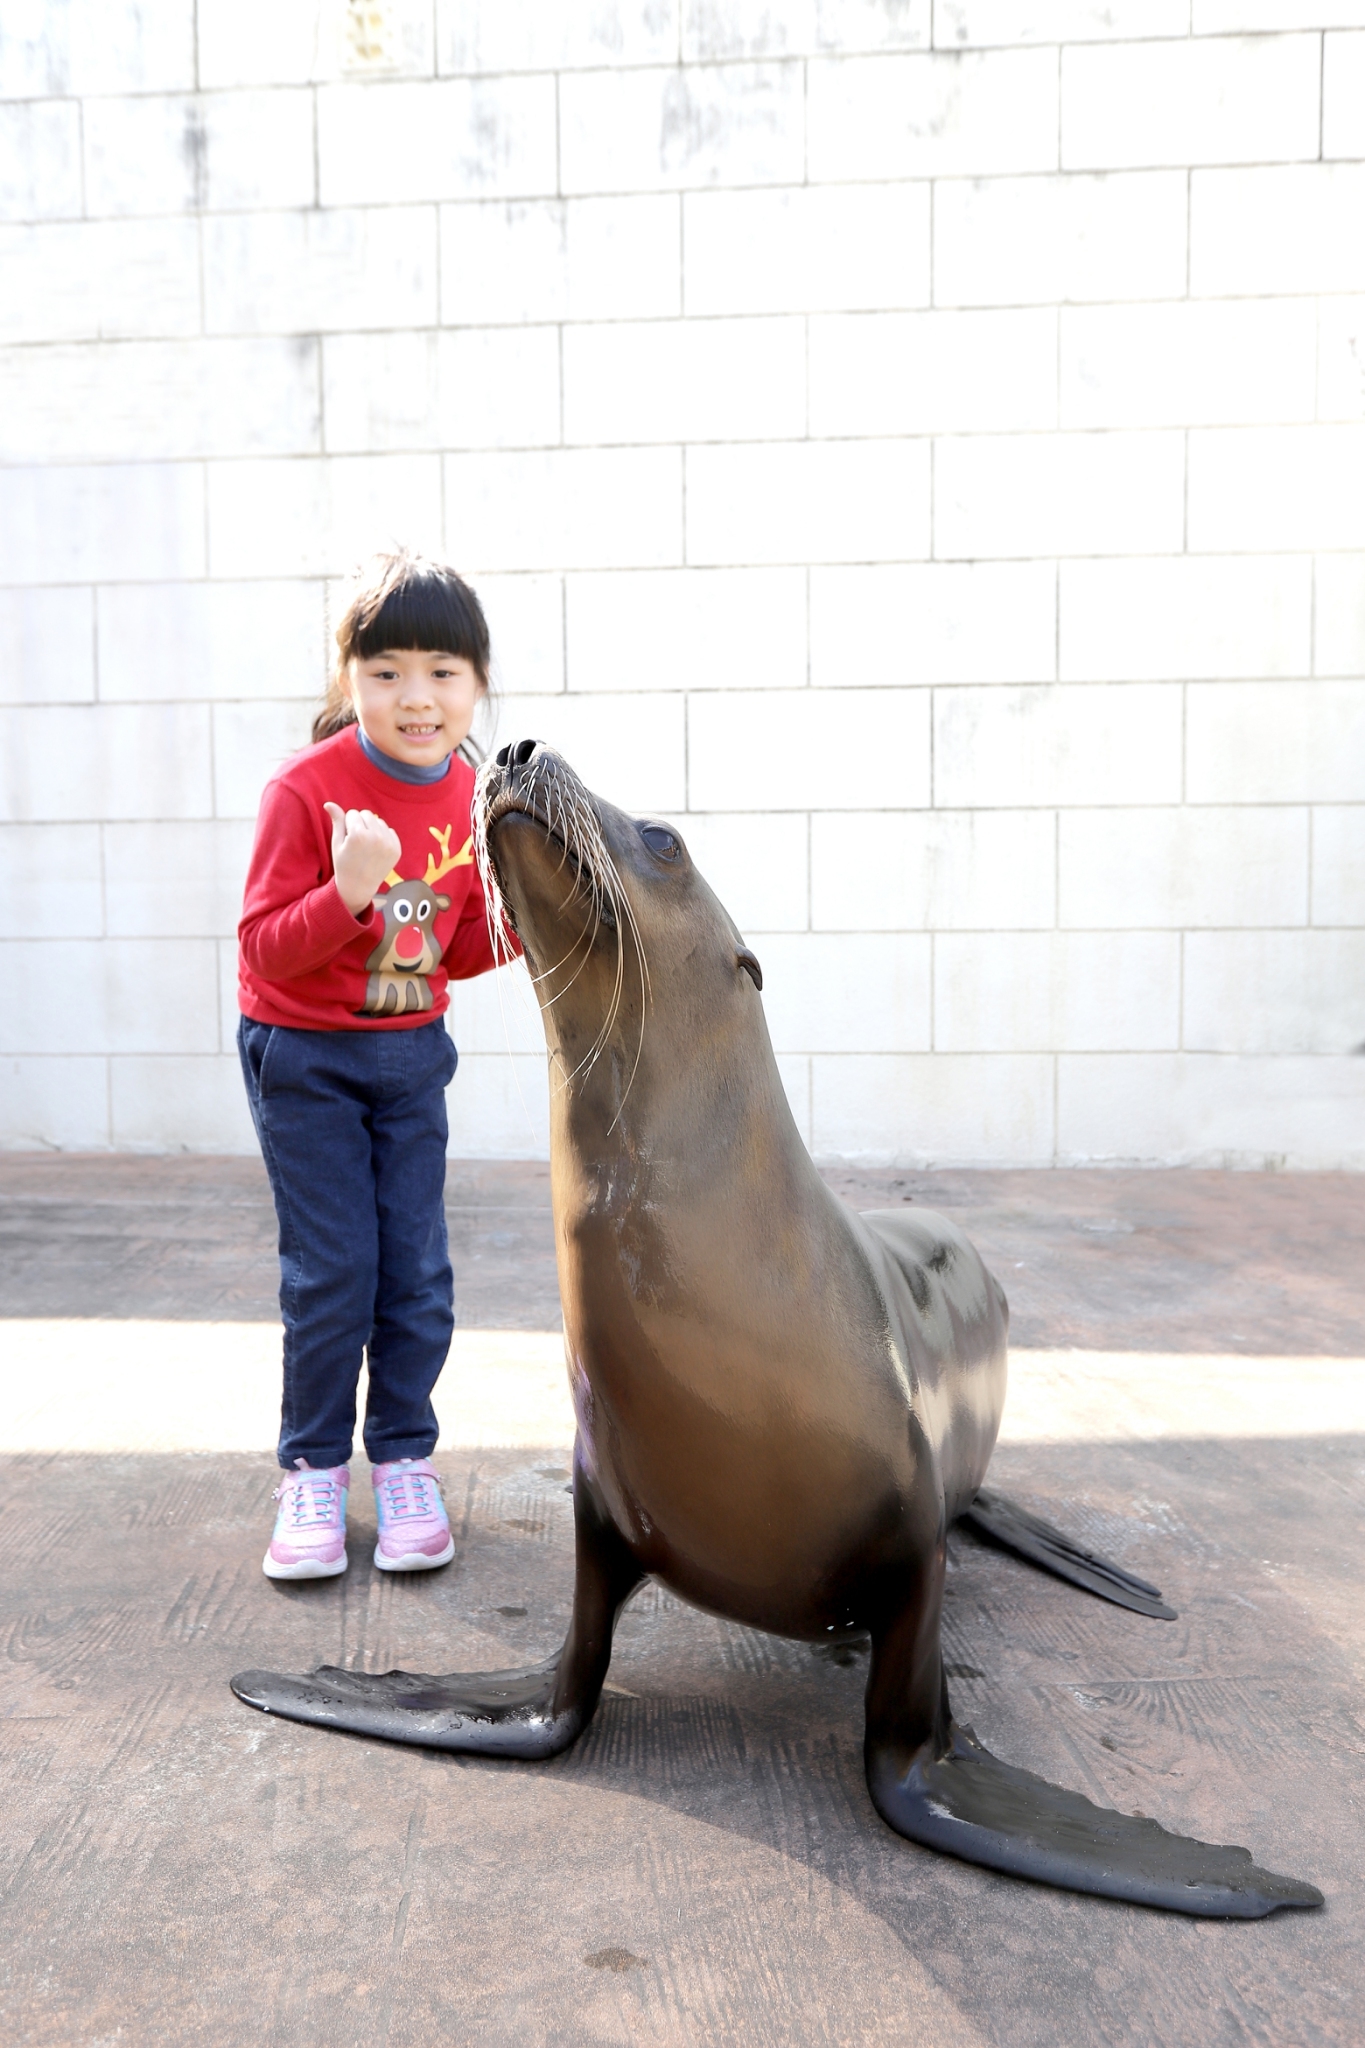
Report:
203,207,436,334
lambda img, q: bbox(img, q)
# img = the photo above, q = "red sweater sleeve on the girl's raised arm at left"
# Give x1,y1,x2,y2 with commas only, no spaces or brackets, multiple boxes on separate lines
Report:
237,782,383,981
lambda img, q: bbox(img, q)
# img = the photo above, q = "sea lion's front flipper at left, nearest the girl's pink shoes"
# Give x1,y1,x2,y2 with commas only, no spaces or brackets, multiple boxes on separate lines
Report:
231,1470,643,1761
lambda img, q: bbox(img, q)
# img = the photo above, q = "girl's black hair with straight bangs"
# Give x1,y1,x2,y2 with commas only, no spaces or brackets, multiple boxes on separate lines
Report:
313,547,491,745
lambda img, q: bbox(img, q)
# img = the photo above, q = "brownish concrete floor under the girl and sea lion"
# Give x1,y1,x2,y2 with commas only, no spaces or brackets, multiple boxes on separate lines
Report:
0,1155,1365,2048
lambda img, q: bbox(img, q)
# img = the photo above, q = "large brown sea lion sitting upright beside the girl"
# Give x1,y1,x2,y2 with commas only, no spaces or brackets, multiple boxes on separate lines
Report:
231,741,1322,1919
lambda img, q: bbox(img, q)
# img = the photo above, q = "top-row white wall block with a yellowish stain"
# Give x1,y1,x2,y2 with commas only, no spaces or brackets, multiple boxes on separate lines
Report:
199,0,436,86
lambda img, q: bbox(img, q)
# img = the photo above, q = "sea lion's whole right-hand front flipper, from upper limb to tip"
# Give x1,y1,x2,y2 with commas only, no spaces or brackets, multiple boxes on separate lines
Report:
864,1536,1322,1919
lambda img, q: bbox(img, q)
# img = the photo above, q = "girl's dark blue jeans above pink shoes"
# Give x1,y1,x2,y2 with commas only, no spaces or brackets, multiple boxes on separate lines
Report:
237,1018,456,1470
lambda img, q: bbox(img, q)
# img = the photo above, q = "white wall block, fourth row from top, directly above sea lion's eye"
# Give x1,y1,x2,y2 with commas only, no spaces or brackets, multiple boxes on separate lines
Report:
563,317,806,444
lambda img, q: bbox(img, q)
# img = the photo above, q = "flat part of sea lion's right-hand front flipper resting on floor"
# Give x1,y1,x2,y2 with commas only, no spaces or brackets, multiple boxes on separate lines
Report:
868,1722,1322,1919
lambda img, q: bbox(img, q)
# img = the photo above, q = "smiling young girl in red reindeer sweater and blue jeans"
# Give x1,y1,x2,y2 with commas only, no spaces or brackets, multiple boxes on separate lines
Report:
237,553,514,1579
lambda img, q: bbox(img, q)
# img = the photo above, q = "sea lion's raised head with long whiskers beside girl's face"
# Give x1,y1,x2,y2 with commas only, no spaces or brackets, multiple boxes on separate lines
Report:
475,739,763,1100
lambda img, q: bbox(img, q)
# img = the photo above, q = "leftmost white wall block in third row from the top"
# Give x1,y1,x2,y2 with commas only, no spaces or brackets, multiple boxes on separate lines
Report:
0,221,199,342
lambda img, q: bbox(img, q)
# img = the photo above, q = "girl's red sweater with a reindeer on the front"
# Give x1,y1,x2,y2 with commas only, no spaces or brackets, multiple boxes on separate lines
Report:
237,725,522,1030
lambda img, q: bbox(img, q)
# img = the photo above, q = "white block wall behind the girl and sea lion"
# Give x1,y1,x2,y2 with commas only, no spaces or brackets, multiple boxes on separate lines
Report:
0,0,1365,1167
